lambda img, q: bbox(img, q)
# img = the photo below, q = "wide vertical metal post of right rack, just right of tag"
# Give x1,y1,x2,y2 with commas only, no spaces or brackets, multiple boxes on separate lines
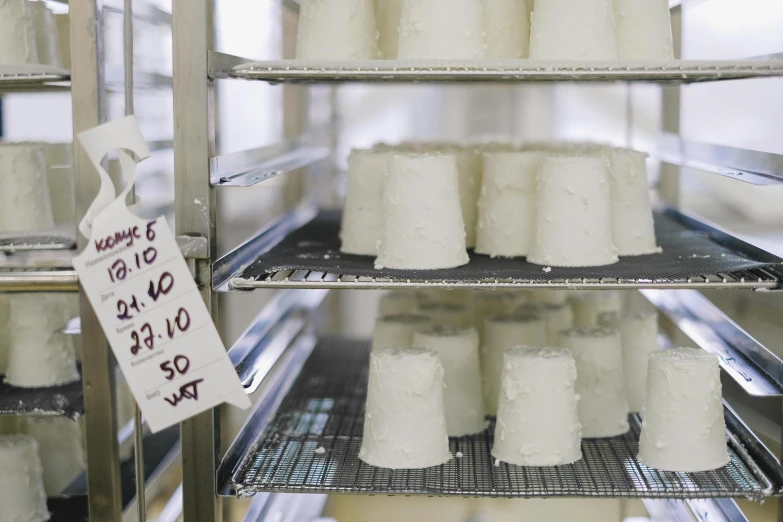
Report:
172,0,222,522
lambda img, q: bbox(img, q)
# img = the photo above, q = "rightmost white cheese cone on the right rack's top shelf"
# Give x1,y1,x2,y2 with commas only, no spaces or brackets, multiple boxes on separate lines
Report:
614,0,674,60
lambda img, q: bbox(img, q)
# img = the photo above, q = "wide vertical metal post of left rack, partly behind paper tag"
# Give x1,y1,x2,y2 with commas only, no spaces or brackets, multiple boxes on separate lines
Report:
69,0,122,522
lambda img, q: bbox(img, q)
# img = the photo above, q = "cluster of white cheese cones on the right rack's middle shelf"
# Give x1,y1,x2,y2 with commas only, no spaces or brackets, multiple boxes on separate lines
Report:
340,143,660,270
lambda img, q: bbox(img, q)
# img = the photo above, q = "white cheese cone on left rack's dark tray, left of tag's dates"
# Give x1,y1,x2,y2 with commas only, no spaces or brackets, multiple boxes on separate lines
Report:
5,294,79,388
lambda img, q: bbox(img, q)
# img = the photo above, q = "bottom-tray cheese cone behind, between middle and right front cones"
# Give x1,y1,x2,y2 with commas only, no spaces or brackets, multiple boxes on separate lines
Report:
559,326,629,438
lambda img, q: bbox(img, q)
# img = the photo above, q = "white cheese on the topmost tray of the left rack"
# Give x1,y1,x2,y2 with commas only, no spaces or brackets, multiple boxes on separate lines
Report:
0,0,70,69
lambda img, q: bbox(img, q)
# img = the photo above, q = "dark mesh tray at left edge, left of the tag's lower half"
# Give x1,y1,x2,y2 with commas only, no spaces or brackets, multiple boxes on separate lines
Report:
0,372,84,419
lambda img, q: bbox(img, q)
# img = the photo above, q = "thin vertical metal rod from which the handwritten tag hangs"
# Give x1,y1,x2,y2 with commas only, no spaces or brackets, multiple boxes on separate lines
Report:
122,0,147,522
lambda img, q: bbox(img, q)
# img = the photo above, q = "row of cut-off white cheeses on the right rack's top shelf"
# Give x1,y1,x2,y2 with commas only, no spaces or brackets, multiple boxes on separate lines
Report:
297,0,674,60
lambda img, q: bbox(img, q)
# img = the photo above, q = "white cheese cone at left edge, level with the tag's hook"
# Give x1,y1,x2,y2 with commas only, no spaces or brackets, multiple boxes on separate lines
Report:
0,142,54,233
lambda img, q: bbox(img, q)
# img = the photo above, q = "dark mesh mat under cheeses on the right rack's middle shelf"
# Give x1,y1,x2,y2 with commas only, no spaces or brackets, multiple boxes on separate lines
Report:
238,211,777,283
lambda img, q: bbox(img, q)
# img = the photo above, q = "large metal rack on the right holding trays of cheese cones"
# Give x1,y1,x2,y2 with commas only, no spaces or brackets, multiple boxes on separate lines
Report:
112,0,783,522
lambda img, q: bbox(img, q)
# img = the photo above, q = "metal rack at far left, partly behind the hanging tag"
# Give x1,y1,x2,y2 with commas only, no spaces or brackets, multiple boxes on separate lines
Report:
0,0,179,521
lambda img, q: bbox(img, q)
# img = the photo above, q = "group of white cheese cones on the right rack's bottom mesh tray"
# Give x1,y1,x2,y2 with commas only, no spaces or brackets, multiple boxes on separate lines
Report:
360,288,728,471
